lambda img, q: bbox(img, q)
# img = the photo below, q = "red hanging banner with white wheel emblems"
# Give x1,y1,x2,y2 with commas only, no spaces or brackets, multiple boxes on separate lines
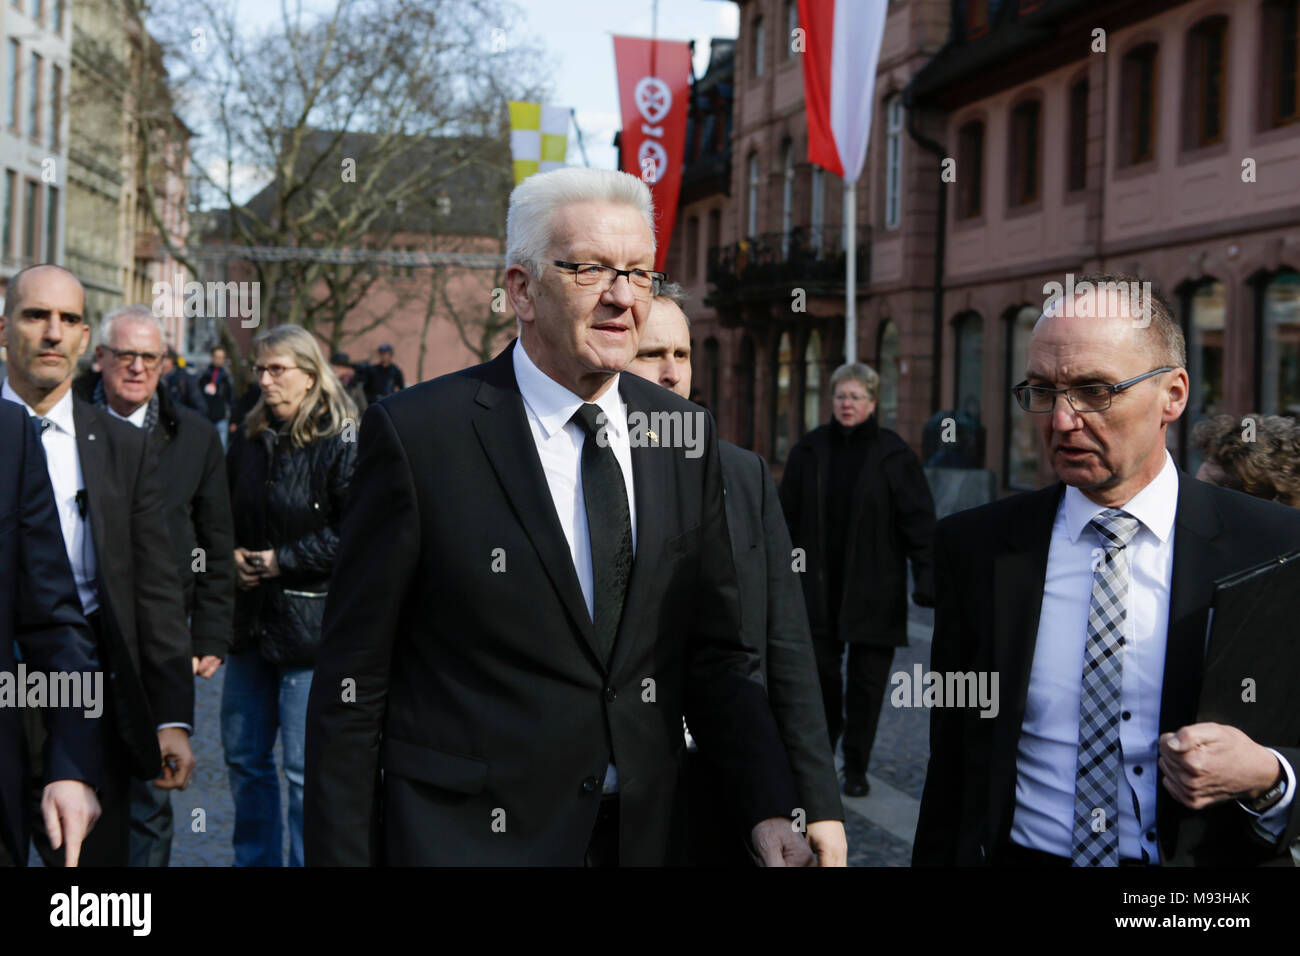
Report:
614,36,692,271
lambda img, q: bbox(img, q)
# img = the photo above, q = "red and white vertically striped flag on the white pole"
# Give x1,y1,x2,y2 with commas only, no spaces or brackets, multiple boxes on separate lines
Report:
800,0,889,182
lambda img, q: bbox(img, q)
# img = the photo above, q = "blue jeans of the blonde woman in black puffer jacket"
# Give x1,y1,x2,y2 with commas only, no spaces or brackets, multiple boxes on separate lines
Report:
221,648,312,866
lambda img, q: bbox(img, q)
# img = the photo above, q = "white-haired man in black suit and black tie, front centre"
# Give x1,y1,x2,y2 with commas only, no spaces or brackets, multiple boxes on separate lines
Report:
304,168,814,866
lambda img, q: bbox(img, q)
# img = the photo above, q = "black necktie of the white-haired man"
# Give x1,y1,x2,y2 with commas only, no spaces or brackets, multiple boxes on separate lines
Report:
571,403,632,661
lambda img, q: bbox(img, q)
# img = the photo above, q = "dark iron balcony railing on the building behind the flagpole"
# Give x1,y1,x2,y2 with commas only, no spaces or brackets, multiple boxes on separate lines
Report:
709,226,871,307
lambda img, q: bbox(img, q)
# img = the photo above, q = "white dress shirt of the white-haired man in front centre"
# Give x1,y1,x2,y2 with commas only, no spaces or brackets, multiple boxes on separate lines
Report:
514,339,637,793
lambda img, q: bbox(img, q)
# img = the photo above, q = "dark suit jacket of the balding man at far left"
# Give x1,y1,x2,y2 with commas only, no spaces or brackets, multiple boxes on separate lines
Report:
73,398,194,779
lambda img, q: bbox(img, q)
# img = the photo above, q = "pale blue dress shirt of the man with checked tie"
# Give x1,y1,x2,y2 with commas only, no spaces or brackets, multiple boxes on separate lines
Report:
1011,451,1295,862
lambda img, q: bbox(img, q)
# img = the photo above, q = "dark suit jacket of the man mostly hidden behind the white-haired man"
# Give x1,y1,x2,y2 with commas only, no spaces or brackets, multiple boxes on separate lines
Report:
718,441,844,822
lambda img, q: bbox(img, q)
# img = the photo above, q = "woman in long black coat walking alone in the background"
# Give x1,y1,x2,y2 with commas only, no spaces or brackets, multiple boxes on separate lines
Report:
780,363,935,796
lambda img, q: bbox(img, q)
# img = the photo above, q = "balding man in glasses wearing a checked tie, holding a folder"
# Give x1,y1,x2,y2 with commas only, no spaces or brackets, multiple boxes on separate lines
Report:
913,276,1300,866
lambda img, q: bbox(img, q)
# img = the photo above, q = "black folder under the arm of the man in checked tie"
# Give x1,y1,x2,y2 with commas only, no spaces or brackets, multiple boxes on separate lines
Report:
1196,550,1300,744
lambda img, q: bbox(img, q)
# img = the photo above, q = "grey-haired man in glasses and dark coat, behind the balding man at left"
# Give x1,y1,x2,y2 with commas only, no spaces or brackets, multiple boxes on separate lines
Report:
75,306,234,866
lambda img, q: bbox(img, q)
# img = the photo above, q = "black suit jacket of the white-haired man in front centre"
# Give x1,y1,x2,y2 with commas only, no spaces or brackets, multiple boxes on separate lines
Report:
303,342,797,865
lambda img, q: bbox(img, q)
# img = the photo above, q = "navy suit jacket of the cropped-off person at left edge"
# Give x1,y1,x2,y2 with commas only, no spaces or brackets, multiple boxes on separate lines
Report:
0,401,104,866
